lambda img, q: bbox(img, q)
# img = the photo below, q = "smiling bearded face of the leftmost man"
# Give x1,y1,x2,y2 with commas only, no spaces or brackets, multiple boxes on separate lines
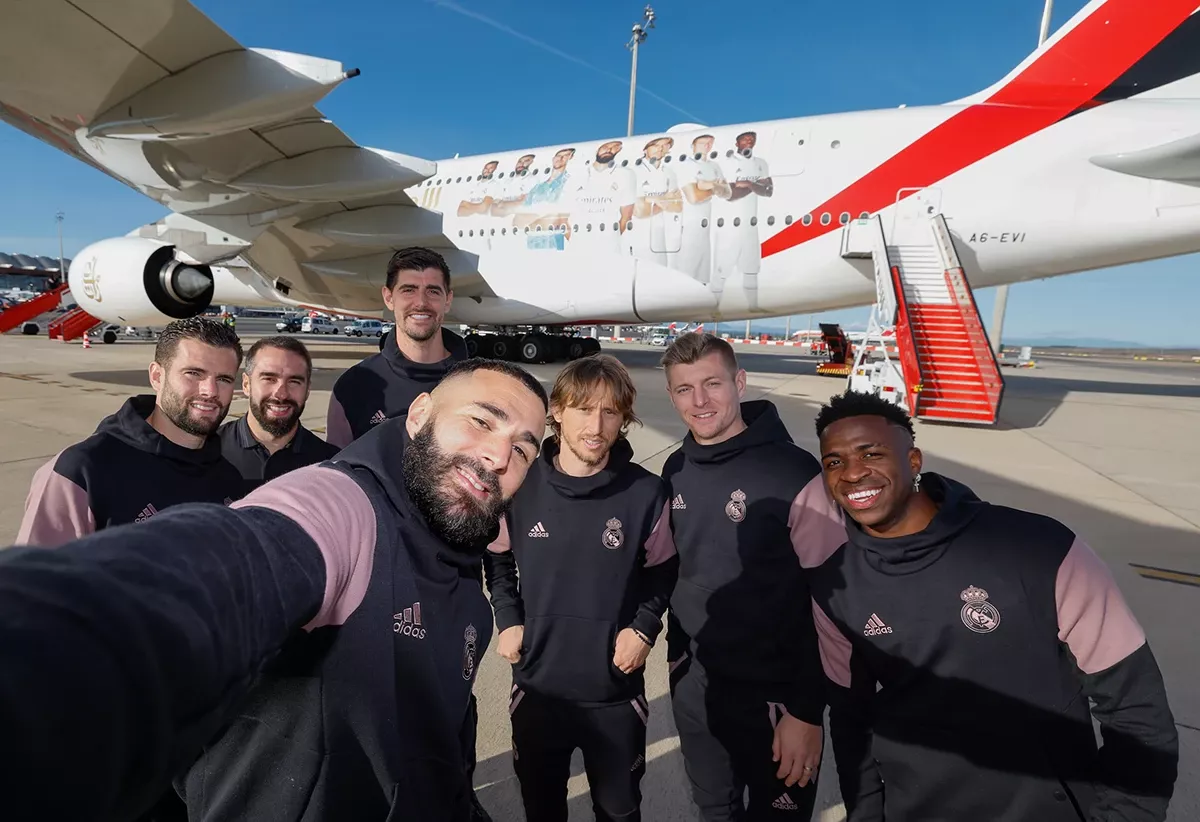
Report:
150,340,238,437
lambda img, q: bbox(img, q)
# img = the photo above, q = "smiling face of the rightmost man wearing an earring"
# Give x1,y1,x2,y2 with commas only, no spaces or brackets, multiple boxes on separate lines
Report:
821,415,922,535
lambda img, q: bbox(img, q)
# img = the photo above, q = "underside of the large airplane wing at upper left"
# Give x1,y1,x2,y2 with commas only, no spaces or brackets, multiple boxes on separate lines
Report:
0,0,490,313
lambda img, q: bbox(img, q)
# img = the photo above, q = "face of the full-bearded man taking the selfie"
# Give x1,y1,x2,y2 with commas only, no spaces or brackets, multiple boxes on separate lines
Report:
404,370,546,545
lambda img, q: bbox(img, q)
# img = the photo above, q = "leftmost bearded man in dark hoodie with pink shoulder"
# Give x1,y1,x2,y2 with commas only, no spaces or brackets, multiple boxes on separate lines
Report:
17,317,242,547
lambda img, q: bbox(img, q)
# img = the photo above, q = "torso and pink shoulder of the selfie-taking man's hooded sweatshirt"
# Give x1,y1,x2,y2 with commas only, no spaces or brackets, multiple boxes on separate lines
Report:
182,420,497,822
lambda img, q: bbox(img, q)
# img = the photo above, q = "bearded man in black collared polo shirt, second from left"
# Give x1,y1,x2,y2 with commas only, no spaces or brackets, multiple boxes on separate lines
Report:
220,336,338,493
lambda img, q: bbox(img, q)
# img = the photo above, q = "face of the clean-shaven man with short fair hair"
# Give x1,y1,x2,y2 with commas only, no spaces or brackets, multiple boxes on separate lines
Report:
667,352,746,445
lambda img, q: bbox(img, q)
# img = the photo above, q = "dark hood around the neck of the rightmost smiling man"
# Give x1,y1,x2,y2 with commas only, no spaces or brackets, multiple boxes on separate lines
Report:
846,473,988,574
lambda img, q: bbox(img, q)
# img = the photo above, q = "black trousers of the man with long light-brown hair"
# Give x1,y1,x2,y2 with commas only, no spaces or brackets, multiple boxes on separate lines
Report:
509,685,650,822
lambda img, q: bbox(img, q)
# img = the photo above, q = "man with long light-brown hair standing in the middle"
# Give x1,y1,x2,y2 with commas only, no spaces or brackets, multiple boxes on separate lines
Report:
484,354,678,822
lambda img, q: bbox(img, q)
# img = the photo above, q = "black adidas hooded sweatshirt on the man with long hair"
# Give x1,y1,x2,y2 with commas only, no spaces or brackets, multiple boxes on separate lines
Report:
485,438,678,706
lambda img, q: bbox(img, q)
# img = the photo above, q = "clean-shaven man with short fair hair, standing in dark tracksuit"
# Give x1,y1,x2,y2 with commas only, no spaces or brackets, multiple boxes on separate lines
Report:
662,331,826,822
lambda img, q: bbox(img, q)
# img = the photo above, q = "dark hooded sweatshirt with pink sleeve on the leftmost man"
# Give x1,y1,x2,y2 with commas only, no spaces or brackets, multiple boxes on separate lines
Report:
17,394,244,547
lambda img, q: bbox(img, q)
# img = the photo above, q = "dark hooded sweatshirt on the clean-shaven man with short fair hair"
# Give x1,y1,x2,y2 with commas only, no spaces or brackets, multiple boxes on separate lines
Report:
662,400,834,725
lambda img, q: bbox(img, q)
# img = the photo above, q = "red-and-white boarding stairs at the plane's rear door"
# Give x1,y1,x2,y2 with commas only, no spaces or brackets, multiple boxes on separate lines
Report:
842,208,1004,425
